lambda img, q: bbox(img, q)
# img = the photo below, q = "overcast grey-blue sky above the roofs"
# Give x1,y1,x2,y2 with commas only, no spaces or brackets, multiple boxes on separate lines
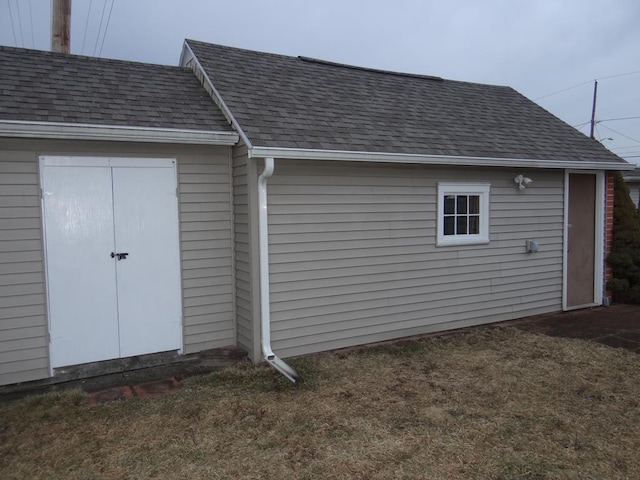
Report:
0,0,640,163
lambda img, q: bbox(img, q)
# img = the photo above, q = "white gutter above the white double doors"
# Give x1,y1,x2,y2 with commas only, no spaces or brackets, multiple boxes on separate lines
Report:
0,120,239,146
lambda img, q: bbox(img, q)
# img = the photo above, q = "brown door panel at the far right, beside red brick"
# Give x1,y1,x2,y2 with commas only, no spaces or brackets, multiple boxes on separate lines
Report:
567,174,596,307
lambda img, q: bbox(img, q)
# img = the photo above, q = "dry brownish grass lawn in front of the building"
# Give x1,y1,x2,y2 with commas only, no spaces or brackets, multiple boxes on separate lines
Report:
0,328,640,480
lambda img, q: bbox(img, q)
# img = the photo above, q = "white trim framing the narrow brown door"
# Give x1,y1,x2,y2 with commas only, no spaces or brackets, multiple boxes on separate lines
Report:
562,170,606,311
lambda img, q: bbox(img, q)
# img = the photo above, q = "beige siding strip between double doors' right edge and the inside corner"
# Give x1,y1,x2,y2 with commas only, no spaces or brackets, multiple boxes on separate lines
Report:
178,149,235,353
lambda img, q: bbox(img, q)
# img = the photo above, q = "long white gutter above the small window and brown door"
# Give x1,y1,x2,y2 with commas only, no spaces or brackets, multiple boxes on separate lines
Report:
249,147,637,170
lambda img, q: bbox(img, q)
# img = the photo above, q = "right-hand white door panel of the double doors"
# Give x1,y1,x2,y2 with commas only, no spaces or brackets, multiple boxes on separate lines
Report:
113,164,182,357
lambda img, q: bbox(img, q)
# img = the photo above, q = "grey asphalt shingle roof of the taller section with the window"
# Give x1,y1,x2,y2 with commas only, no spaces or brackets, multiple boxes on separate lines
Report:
187,40,624,163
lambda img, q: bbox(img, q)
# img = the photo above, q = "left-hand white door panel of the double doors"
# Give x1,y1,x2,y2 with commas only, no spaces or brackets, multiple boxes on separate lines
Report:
43,166,119,368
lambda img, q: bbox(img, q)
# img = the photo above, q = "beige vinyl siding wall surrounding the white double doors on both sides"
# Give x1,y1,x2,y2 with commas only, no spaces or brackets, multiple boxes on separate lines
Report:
0,140,235,384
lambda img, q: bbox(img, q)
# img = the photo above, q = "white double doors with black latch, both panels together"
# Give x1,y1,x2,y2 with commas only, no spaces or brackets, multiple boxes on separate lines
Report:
40,157,182,368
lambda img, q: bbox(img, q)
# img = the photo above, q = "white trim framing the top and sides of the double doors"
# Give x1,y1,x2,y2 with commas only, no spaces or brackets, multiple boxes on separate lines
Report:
38,155,185,376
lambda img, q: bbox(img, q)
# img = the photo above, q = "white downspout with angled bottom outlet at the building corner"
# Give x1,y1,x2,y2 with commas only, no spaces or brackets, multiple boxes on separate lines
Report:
258,157,302,383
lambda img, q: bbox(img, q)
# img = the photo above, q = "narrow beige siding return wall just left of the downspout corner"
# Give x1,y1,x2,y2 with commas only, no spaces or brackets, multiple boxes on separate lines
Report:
233,146,259,352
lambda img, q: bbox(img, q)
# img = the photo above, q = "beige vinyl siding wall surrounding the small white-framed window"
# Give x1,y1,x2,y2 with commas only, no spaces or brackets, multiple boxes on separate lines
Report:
269,161,563,357
